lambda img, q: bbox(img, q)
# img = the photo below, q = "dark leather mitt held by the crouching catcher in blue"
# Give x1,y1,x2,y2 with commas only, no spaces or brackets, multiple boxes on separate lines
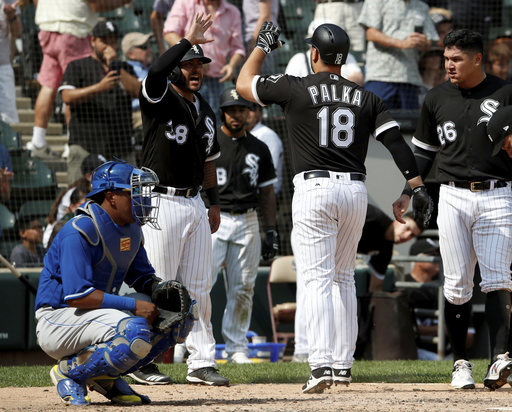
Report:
151,280,192,332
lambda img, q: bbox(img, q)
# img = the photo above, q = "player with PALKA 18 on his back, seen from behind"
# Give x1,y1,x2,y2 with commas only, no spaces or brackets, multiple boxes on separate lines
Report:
237,22,432,393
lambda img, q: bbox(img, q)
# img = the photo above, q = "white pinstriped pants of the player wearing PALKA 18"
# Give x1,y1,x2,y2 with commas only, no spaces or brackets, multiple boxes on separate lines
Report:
292,172,368,370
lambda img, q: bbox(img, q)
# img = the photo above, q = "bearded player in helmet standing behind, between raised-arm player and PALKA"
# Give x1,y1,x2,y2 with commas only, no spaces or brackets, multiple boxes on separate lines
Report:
203,87,277,363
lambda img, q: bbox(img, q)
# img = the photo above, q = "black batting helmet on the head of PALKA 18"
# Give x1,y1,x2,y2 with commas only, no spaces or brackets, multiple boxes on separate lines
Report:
304,23,350,65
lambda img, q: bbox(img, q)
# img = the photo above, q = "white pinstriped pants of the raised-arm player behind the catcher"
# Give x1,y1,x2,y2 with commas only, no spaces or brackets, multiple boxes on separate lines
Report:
142,193,217,373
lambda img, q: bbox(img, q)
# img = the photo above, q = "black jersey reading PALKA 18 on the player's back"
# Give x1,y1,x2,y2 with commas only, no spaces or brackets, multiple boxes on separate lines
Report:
253,72,398,174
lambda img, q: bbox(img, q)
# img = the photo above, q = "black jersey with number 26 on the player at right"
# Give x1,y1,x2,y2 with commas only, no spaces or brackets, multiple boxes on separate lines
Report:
412,74,512,183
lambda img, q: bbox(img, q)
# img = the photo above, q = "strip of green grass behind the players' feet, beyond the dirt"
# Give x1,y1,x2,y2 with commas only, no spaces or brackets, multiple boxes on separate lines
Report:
0,360,488,388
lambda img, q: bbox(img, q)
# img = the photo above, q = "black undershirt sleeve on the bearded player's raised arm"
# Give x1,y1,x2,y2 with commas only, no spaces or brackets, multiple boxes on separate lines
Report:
145,38,192,98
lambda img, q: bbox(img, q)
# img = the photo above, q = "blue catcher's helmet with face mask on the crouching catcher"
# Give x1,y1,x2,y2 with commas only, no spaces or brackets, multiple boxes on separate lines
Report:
87,160,160,230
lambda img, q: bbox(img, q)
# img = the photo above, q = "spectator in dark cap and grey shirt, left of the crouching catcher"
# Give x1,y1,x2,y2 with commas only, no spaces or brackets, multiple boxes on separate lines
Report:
11,216,46,268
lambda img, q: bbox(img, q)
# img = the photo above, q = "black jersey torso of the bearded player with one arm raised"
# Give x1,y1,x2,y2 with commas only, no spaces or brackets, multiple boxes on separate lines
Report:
139,80,219,188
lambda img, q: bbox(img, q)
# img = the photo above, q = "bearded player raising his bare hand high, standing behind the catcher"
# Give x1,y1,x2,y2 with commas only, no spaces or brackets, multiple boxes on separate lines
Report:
133,14,229,386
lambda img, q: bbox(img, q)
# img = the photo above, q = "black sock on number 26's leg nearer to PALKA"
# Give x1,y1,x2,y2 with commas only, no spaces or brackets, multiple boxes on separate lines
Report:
444,299,471,360
